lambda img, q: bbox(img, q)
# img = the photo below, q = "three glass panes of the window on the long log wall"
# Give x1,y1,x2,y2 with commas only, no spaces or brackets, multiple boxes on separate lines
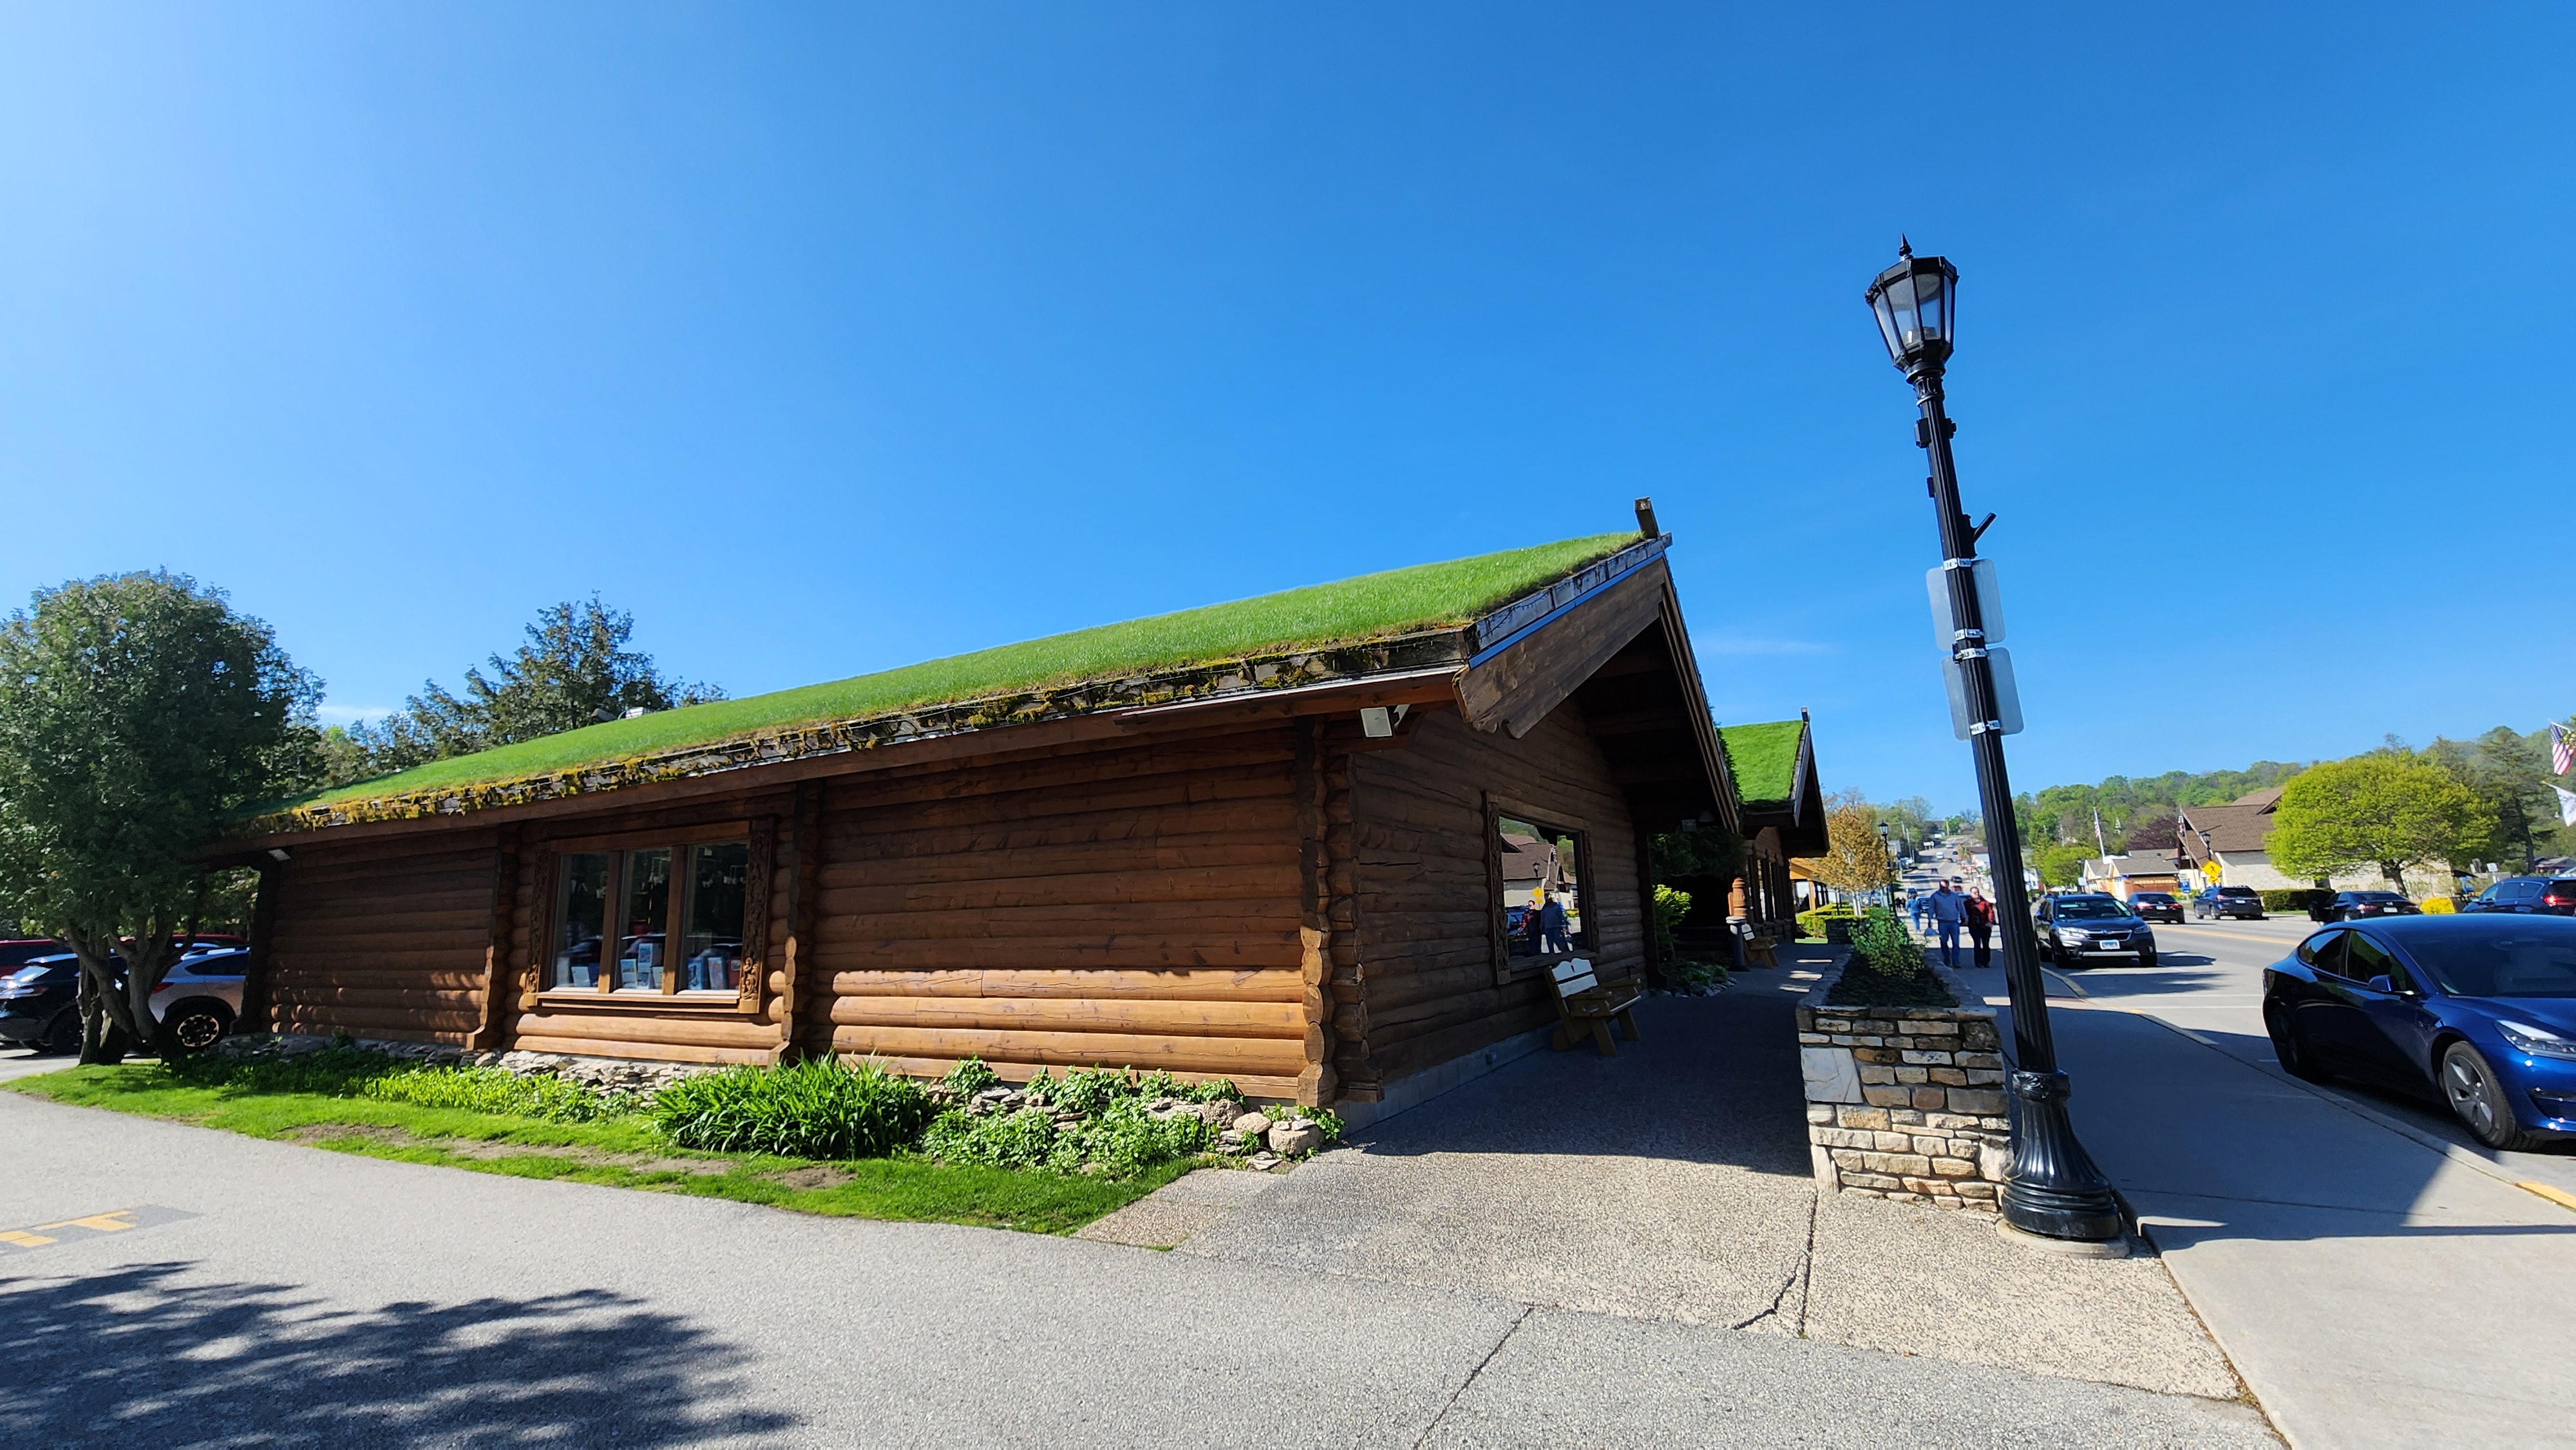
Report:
546,840,752,997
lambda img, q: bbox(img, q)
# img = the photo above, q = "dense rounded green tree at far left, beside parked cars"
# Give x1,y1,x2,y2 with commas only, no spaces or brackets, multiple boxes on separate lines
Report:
0,572,322,1061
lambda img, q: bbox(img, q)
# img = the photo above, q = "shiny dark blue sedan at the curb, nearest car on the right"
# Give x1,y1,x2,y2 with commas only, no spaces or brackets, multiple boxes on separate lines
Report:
2262,914,2576,1149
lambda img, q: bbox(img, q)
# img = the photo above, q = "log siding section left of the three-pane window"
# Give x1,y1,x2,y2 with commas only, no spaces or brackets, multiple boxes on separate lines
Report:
268,832,500,1043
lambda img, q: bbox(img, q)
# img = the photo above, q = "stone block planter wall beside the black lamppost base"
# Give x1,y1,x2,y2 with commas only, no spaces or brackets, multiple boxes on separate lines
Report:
1798,968,2012,1213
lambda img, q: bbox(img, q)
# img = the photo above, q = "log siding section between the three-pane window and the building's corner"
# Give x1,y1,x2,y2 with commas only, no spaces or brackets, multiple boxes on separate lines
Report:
799,726,1321,1097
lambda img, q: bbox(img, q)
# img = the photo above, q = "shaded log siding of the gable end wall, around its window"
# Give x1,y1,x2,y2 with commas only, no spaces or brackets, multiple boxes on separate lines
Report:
1334,706,1646,1095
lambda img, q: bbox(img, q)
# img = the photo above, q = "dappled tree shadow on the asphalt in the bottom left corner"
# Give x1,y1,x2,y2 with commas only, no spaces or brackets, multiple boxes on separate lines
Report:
0,1262,796,1445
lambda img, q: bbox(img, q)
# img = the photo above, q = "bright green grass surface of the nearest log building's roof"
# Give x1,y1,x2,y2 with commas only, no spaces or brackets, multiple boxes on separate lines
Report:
296,533,1636,809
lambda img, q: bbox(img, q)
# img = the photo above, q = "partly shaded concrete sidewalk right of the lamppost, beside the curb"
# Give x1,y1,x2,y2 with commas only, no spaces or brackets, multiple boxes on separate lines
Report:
2050,999,2576,1447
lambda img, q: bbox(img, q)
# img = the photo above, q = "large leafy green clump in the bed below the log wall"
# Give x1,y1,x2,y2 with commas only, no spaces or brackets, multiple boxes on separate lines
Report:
649,1059,933,1159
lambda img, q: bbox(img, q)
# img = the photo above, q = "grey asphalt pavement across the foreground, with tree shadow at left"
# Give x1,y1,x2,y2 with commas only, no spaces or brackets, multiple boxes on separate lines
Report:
0,1051,2272,1450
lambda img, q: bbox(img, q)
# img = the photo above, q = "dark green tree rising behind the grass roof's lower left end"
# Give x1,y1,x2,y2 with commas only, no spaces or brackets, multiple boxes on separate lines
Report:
337,595,724,780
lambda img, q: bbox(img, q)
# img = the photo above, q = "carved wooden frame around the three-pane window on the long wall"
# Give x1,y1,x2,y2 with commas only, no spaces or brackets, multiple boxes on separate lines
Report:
523,816,778,1017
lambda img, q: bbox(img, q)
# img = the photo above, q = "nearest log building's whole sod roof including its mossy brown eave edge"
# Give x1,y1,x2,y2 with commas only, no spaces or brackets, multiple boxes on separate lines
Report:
232,533,1628,837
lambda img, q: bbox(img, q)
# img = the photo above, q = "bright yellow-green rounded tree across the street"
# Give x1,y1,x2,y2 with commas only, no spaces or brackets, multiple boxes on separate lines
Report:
2264,749,2496,891
